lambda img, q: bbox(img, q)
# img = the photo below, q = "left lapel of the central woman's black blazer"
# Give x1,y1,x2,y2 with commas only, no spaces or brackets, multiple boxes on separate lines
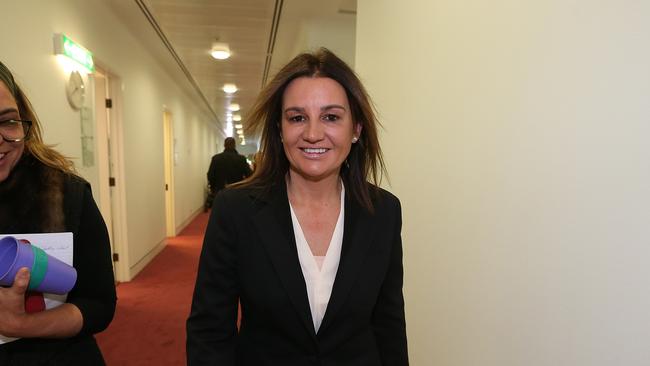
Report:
253,186,316,340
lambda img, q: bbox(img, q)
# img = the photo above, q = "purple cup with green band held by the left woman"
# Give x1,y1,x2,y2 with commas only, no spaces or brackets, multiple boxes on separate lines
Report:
0,236,77,295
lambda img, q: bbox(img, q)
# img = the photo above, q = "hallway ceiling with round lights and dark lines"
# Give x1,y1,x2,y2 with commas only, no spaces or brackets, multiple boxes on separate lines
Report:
112,0,356,146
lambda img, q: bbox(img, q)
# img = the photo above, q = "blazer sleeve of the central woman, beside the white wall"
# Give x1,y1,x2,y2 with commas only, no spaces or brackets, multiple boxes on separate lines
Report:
372,198,409,366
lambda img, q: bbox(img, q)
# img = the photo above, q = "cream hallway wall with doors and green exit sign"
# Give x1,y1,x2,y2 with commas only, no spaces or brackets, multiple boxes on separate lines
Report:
0,0,222,275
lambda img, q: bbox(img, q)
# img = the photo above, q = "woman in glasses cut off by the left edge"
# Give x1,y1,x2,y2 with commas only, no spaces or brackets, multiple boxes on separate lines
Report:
0,63,116,366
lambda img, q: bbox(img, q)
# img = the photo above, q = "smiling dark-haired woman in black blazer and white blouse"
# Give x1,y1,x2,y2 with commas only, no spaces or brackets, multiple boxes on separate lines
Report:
187,49,408,366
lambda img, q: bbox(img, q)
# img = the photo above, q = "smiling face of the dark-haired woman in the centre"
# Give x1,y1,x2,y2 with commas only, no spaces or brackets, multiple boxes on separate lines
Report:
281,77,361,186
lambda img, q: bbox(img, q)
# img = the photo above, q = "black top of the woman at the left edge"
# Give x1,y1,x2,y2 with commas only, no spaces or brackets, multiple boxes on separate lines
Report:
0,155,116,366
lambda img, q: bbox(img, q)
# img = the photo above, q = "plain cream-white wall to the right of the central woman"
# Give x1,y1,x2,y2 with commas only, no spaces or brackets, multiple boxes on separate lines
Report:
356,0,650,366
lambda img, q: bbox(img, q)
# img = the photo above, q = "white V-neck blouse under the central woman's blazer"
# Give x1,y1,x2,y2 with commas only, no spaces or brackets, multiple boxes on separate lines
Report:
289,182,345,333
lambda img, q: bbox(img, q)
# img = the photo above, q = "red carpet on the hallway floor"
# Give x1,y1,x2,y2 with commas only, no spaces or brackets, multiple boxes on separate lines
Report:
96,213,209,366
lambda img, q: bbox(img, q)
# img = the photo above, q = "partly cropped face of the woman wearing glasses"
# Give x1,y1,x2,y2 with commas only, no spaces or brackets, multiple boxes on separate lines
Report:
0,81,25,183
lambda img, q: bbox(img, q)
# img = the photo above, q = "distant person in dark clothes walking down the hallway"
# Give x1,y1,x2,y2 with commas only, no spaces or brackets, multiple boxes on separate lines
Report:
206,137,251,208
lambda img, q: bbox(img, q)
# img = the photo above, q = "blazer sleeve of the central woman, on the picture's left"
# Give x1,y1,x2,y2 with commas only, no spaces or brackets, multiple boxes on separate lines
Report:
187,191,239,366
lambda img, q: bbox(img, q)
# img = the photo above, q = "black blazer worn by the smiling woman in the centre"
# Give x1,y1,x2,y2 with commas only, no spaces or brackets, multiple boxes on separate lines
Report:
187,184,408,366
